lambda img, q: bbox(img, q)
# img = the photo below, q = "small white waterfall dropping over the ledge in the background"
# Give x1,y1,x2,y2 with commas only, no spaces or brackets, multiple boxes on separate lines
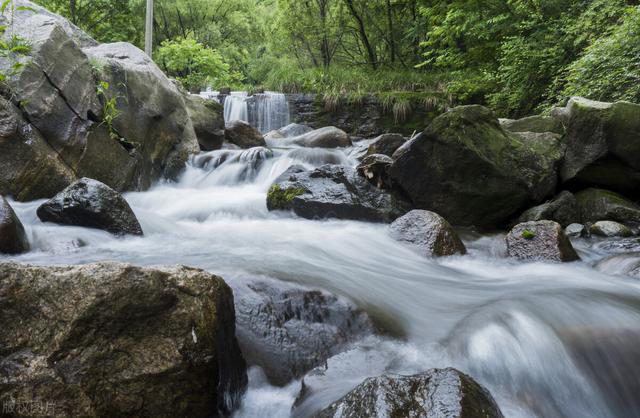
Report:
224,92,289,134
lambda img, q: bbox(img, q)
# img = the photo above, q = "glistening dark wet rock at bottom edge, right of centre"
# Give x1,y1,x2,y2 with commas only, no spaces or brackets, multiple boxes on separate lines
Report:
316,369,503,418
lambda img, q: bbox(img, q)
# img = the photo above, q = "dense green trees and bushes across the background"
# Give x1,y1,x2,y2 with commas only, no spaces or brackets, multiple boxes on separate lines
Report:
32,0,640,116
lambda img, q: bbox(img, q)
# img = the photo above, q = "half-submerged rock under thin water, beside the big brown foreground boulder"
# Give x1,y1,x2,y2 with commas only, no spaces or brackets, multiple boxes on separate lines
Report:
234,280,374,385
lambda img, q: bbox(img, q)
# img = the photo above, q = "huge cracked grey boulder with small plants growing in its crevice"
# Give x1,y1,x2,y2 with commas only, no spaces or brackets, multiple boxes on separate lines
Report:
0,0,197,200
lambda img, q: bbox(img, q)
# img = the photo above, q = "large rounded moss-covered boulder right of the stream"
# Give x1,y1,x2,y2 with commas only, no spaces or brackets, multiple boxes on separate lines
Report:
390,105,563,228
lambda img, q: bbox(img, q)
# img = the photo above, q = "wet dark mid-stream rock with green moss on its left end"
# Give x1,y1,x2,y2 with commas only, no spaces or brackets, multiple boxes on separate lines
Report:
267,165,408,222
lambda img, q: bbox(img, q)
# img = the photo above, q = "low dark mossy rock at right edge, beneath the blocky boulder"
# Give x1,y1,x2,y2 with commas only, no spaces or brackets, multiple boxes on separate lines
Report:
576,188,640,224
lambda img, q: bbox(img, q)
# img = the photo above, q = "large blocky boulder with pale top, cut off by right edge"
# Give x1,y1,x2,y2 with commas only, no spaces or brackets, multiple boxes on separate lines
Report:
557,97,640,194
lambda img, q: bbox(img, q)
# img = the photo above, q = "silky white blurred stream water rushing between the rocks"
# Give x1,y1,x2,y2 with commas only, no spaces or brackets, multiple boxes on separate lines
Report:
3,144,640,418
